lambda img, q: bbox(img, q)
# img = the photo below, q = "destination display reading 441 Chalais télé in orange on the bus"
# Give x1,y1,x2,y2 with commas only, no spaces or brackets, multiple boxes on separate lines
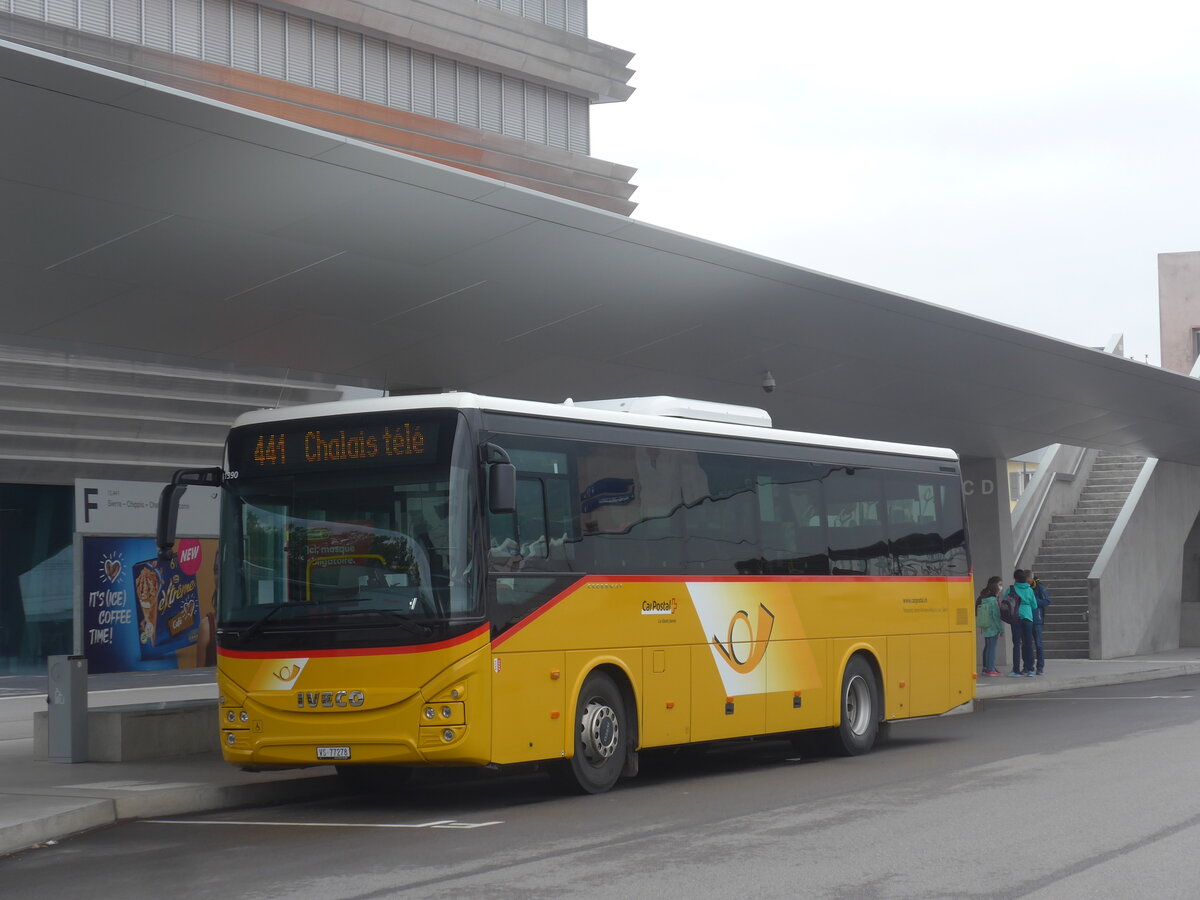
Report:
229,416,446,476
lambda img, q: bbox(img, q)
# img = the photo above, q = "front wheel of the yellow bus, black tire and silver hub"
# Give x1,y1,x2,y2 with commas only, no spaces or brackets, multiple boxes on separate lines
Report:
569,672,630,793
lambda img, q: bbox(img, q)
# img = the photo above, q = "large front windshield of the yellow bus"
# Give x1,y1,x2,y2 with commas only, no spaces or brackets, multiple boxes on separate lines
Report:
217,419,481,649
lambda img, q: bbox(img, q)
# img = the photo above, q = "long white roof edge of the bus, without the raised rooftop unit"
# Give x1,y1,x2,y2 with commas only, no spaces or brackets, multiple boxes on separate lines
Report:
234,391,959,461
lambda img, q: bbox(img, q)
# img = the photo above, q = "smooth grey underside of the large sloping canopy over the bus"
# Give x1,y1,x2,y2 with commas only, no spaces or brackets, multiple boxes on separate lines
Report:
7,42,1200,463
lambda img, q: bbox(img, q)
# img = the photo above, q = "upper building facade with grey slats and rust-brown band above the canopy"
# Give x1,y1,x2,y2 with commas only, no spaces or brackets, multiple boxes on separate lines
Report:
0,0,635,215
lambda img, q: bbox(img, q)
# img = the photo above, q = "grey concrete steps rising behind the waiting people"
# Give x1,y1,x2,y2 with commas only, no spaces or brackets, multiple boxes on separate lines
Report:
1033,452,1146,659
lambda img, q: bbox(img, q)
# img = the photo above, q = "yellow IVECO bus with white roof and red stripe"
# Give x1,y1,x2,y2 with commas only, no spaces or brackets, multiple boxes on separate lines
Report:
158,392,974,793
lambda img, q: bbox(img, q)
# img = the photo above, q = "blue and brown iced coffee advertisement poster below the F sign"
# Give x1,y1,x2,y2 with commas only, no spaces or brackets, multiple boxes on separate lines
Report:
83,536,217,674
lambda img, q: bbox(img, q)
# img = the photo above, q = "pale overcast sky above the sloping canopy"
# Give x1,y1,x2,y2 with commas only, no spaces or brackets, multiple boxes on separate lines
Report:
589,0,1200,365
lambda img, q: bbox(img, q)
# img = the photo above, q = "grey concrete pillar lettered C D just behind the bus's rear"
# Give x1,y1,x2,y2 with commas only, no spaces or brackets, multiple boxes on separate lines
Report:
959,456,1016,670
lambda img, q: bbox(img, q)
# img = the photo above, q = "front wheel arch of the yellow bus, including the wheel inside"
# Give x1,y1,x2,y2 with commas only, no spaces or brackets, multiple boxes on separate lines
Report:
562,665,637,793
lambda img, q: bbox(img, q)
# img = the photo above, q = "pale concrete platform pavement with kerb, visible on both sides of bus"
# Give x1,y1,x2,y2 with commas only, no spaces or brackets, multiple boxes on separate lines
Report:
0,648,1200,857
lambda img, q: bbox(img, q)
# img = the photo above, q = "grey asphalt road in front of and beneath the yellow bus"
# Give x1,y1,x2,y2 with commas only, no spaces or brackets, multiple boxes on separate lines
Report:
0,677,1200,900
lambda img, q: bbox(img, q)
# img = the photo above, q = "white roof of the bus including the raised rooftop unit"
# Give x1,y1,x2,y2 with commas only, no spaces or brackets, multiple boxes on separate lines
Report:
234,391,958,461
